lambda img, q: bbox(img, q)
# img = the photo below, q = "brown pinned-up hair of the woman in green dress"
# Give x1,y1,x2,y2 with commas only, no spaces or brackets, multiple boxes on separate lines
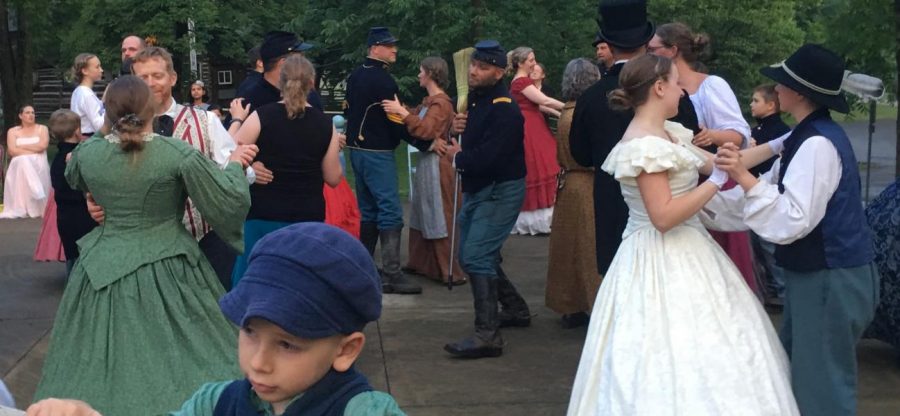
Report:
103,75,153,152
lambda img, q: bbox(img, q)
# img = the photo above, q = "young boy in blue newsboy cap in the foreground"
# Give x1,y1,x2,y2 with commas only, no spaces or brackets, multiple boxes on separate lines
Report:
29,222,405,416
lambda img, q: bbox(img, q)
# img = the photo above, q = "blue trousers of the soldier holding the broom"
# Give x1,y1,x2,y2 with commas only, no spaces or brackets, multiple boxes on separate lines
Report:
459,178,525,277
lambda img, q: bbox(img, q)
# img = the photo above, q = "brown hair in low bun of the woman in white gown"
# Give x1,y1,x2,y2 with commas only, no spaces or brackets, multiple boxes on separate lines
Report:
607,54,672,111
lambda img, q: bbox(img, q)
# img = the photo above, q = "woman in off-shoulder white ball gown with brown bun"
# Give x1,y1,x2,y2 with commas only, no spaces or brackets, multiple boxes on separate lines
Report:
568,55,799,416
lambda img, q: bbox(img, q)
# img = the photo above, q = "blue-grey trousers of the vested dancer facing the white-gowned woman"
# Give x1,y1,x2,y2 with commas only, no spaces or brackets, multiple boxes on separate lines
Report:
780,264,880,416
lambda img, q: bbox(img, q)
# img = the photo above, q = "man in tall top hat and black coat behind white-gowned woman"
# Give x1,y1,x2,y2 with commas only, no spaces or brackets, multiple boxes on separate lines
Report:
569,0,699,275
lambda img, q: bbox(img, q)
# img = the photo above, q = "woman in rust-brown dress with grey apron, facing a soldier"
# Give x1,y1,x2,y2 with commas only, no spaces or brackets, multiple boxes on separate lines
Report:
382,57,465,283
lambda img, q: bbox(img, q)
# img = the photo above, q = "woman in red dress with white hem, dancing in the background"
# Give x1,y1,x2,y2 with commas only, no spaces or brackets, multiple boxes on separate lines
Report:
507,46,563,235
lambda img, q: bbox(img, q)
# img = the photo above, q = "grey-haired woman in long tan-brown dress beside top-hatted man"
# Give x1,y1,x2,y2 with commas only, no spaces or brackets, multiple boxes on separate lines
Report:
546,58,601,328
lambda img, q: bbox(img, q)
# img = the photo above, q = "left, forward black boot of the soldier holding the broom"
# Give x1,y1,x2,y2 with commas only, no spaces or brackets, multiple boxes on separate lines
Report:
444,275,503,358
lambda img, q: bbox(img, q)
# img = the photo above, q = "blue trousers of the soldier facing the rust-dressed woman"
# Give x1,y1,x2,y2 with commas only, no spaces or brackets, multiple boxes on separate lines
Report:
350,149,403,230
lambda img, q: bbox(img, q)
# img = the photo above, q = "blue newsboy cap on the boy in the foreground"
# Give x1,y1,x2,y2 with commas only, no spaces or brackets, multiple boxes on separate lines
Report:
219,222,381,339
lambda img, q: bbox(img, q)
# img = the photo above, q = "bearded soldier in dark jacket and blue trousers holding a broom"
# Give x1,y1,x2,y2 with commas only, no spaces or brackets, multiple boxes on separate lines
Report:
444,40,531,358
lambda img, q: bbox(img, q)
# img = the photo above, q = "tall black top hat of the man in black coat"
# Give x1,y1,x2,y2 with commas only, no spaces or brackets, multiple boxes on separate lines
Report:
595,0,656,49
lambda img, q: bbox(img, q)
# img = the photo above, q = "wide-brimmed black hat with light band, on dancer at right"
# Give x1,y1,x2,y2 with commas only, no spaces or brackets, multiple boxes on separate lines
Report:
759,44,850,113
